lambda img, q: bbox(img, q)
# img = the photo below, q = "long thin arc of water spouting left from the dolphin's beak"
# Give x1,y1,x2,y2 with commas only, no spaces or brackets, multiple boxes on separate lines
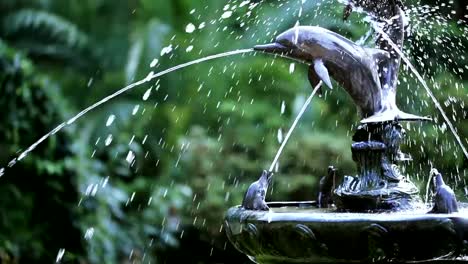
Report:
0,49,253,177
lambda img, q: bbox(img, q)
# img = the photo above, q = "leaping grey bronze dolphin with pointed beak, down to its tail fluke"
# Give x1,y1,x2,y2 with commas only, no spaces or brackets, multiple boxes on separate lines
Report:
254,26,427,123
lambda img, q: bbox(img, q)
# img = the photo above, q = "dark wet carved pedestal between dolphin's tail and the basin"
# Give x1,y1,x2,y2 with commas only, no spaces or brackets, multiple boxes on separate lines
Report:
334,122,421,212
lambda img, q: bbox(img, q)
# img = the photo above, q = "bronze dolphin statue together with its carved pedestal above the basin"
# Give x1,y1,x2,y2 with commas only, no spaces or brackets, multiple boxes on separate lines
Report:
250,0,430,211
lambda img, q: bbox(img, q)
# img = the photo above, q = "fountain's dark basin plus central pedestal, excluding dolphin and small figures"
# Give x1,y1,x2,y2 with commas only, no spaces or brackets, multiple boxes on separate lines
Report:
224,122,468,264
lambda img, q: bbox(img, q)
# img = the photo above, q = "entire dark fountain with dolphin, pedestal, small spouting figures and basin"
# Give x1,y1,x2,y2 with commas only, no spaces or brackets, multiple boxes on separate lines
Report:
225,0,468,263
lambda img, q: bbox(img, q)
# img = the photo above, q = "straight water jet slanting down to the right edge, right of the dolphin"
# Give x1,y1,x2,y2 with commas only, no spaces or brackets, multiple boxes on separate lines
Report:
371,23,468,159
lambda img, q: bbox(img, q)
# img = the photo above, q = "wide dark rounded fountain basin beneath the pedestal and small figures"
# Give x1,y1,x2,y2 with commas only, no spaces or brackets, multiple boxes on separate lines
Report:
224,202,468,263
